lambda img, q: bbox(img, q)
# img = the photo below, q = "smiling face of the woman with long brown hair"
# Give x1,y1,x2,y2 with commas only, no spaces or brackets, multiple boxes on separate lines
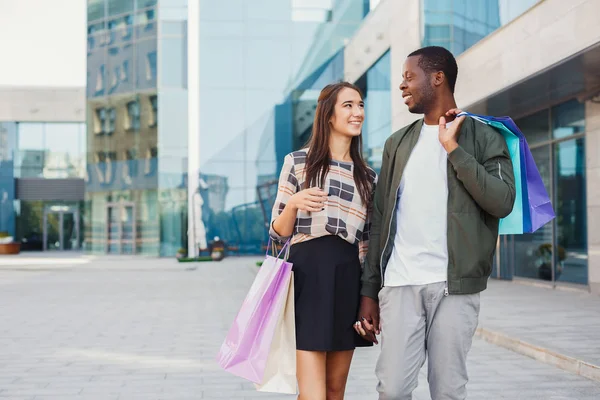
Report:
329,88,365,137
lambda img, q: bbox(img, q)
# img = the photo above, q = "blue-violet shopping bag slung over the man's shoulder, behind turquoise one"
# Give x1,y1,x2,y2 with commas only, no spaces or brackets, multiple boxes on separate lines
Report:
465,113,556,233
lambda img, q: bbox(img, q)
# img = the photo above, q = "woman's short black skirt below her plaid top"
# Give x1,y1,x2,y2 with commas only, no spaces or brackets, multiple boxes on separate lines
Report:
289,235,373,351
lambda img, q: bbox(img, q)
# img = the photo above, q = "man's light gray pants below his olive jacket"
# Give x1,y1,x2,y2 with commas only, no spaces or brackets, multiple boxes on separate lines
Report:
375,282,479,400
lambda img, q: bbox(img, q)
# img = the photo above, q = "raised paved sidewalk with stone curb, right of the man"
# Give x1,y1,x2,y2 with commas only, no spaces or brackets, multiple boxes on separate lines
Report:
478,280,600,381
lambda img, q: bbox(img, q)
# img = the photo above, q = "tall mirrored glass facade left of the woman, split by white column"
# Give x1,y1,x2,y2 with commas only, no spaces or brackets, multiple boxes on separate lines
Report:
85,0,370,256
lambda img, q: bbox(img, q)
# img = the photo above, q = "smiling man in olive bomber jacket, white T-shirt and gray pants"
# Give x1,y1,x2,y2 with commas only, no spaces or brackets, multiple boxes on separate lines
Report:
357,47,515,400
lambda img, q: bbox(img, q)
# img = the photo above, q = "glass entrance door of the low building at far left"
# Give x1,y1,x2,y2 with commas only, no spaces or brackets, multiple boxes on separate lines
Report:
43,206,80,250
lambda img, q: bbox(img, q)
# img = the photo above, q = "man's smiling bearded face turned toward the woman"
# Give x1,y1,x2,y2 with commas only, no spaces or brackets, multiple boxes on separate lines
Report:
400,56,435,114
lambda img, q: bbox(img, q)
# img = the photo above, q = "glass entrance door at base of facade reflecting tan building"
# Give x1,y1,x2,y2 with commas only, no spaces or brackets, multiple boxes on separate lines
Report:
106,202,137,254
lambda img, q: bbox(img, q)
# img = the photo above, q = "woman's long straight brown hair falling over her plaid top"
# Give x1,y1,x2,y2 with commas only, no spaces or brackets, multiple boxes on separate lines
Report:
305,82,372,207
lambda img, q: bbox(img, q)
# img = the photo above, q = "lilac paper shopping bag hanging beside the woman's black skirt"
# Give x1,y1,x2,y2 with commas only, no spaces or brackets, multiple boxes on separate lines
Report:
217,241,292,384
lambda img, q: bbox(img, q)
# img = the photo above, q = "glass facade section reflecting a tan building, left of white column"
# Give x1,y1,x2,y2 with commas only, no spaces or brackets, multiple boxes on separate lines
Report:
85,0,187,255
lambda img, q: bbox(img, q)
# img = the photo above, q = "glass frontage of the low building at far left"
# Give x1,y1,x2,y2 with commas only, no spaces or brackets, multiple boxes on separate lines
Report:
0,122,86,250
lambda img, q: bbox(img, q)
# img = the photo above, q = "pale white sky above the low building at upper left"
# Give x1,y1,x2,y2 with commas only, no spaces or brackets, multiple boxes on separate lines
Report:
0,0,87,87
